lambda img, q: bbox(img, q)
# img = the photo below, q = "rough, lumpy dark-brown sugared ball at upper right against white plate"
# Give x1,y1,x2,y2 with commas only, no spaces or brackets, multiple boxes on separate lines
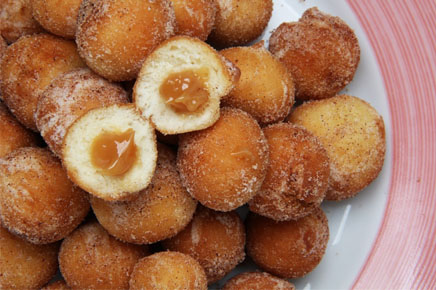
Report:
269,7,360,100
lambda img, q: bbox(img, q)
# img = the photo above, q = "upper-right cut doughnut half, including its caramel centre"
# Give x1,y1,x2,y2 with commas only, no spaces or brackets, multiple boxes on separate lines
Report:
133,36,239,134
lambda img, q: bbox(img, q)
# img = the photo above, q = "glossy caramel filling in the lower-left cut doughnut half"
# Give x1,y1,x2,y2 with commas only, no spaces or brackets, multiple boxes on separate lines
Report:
91,129,136,176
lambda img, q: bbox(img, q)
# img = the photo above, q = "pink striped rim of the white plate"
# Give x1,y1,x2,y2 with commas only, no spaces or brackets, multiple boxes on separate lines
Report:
348,0,436,289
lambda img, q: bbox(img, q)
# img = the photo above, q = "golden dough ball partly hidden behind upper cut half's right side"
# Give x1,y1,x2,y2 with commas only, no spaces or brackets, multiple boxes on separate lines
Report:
220,42,294,124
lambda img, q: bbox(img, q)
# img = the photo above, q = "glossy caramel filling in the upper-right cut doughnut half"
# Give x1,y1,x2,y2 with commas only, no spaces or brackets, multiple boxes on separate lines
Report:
159,70,209,113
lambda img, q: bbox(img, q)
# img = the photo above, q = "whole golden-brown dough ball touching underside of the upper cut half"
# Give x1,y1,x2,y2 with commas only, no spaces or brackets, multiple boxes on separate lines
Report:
177,108,268,211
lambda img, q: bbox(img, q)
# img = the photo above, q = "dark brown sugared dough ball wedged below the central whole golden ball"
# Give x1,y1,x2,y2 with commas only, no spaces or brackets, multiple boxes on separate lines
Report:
163,206,245,284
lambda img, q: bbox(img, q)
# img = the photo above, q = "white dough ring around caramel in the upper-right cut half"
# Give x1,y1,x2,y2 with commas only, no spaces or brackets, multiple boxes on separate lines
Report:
134,39,233,134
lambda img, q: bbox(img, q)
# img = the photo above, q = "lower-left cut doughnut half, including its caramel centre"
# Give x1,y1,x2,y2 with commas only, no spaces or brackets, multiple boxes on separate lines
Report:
62,104,157,201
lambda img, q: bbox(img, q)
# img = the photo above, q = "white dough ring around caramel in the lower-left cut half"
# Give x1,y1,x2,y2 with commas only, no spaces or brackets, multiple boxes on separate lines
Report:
63,105,157,199
